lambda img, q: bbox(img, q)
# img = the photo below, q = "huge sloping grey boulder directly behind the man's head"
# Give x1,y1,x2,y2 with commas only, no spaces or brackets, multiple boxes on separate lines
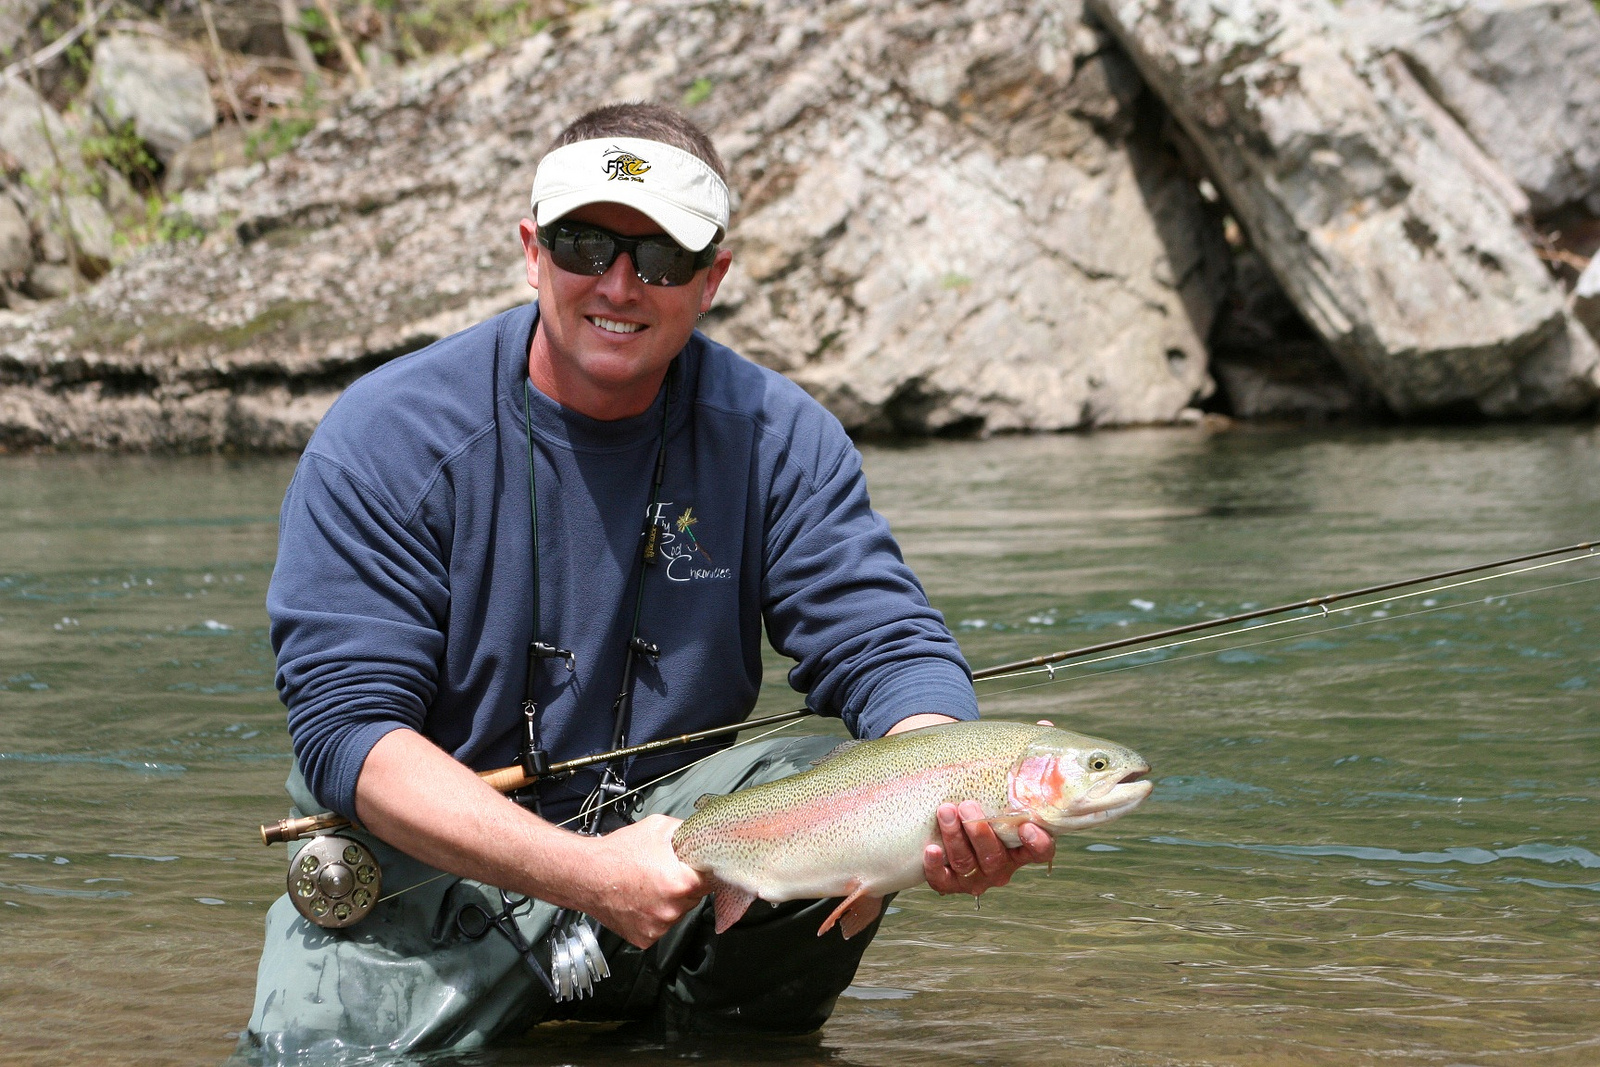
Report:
0,0,1226,448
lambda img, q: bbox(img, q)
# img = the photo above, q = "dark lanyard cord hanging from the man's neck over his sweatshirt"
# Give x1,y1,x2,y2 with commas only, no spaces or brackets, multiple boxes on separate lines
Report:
522,367,678,832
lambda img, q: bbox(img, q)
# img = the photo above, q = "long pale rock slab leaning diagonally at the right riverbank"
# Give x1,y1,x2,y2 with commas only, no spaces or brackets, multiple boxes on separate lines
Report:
1093,0,1597,414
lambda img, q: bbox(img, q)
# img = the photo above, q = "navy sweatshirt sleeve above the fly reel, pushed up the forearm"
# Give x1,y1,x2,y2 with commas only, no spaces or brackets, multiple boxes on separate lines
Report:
267,453,450,817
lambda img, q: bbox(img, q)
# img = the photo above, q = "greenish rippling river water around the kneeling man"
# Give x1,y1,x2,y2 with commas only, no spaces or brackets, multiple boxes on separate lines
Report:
0,427,1600,1065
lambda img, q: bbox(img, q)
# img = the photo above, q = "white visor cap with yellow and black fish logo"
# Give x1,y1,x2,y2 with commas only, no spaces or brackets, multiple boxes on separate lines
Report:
531,138,728,251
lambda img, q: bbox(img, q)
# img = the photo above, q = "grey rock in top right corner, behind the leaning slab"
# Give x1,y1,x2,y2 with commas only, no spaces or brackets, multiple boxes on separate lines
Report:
1341,0,1600,214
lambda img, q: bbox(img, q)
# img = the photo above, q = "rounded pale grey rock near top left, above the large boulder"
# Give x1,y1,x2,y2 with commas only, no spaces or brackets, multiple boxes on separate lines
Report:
90,34,216,163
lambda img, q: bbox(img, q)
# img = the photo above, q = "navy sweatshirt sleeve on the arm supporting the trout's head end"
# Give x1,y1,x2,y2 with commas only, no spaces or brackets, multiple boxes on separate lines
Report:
763,419,978,737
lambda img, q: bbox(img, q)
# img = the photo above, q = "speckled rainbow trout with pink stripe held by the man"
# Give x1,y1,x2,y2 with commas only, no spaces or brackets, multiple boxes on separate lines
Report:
672,721,1150,937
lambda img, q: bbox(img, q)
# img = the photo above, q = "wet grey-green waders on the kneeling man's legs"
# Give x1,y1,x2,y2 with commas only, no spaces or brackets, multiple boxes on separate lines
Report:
240,737,877,1062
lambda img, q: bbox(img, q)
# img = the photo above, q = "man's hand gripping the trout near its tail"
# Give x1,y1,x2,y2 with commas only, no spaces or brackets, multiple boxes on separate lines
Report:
584,816,710,949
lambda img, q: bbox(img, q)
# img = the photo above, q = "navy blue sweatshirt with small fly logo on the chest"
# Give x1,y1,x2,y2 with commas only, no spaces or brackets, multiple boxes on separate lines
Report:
267,304,978,819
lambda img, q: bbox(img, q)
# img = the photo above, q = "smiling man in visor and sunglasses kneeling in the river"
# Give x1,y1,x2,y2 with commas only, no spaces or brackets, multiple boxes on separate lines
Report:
245,104,1053,1057
